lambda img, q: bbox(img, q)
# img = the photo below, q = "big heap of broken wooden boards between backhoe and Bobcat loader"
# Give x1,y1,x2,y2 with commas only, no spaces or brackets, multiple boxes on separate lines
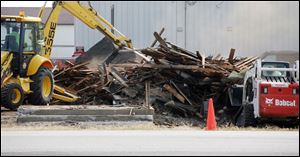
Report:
55,29,257,125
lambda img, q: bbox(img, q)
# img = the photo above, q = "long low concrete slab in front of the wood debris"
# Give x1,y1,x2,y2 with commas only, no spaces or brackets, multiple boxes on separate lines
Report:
17,106,154,123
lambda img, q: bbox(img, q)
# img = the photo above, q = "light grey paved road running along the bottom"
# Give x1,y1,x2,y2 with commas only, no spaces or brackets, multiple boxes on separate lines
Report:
1,130,299,156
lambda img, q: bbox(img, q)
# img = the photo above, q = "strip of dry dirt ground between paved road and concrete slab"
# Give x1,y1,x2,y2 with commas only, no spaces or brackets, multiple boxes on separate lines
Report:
1,108,299,131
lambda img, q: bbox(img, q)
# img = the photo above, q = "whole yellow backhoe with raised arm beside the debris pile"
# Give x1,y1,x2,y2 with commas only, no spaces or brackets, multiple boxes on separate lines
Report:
1,1,133,110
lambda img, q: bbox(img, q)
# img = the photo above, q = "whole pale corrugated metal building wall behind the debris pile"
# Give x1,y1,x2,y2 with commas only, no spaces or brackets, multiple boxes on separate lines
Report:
75,1,299,56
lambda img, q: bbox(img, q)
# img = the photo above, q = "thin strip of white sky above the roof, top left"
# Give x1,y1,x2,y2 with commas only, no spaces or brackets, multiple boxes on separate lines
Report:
1,1,53,7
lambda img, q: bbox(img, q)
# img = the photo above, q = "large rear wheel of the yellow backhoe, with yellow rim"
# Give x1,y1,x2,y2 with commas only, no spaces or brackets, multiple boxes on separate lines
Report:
28,67,54,105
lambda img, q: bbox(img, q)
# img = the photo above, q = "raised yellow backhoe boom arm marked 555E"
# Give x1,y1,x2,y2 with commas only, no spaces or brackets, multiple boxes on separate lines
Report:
39,1,133,58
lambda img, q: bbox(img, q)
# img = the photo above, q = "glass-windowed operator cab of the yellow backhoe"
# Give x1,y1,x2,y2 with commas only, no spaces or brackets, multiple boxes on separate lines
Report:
1,14,43,77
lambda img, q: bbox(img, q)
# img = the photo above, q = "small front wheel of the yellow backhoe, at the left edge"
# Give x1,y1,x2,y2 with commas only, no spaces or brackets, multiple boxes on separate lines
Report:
1,83,24,111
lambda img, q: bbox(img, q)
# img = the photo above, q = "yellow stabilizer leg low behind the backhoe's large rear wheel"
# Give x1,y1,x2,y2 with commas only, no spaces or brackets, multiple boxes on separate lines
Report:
53,85,80,102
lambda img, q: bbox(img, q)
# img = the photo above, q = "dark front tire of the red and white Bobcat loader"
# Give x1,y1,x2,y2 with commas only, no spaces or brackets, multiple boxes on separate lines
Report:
236,104,256,127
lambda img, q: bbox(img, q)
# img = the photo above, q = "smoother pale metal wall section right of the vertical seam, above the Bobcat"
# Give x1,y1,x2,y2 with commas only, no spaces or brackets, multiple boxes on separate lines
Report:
187,2,299,56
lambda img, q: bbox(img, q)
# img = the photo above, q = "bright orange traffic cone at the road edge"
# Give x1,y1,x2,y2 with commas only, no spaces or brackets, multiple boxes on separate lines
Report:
206,98,217,130
